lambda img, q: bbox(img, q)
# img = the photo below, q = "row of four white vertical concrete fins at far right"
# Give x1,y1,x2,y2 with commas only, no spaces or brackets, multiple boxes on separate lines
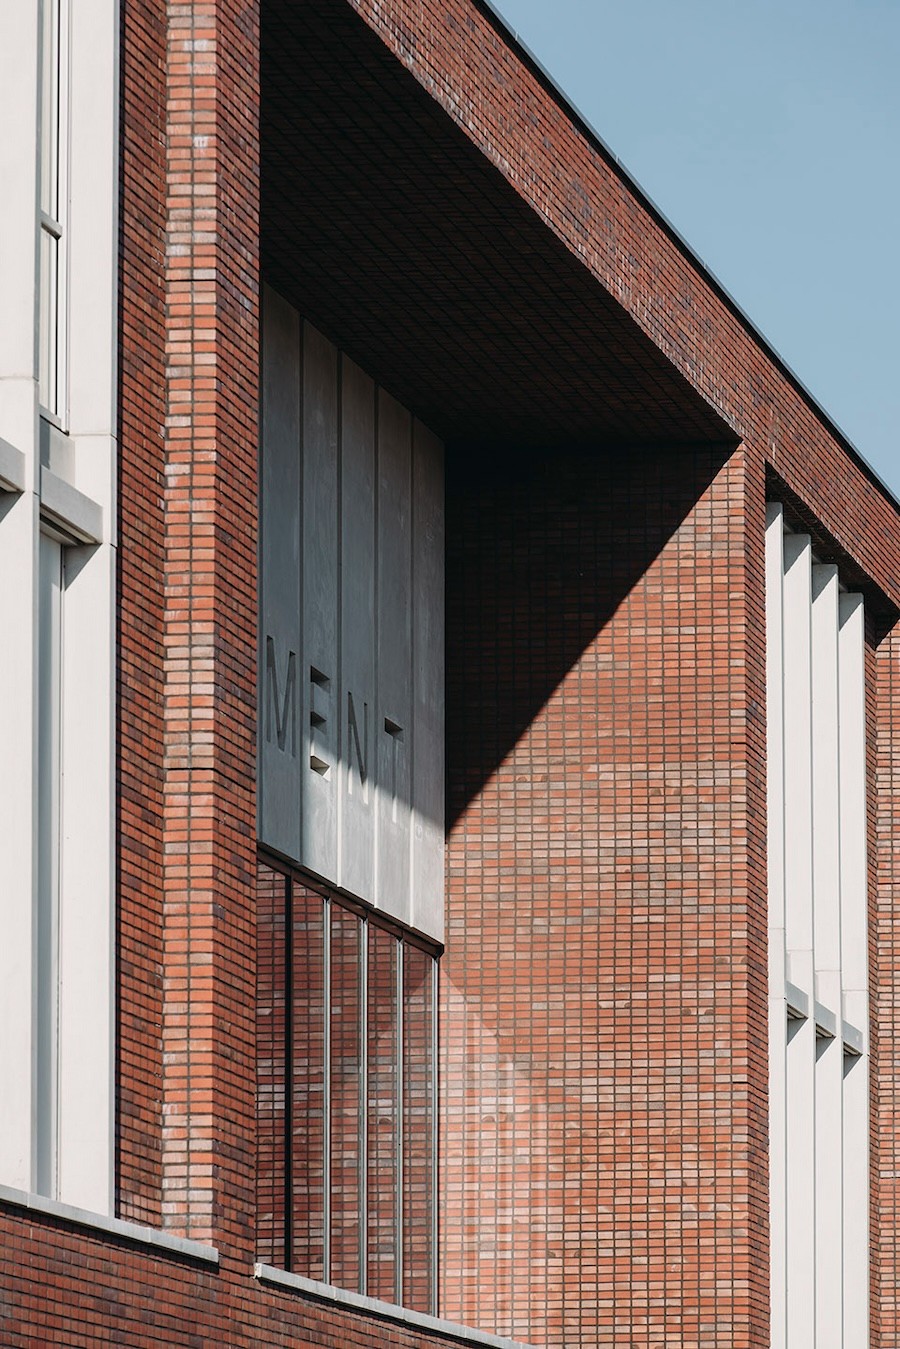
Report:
766,505,869,1349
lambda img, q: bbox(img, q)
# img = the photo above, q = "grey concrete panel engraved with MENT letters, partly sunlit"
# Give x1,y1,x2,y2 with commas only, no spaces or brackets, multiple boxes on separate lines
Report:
259,291,444,938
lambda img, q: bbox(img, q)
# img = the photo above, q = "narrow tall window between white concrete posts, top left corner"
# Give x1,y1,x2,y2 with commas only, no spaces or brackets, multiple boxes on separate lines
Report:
38,0,69,420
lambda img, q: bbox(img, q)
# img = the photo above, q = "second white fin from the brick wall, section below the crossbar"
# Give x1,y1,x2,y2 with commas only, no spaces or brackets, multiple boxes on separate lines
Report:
785,1018,816,1349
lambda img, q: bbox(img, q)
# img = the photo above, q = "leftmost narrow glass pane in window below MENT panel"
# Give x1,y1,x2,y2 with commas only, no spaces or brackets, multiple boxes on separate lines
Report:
256,862,287,1268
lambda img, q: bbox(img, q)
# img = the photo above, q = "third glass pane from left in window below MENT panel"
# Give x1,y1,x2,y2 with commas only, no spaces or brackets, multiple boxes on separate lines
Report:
329,904,362,1290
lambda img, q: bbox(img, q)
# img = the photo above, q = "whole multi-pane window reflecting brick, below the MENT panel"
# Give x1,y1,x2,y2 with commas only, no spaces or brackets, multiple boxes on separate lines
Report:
256,861,437,1311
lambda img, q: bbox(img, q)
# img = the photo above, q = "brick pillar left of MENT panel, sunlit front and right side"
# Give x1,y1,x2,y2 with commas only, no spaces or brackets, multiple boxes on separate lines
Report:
163,0,259,1256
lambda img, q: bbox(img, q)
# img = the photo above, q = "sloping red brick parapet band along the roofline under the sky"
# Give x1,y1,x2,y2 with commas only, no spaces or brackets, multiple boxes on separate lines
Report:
348,0,900,604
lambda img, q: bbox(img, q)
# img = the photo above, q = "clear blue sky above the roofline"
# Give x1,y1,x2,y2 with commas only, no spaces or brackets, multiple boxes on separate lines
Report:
494,0,900,494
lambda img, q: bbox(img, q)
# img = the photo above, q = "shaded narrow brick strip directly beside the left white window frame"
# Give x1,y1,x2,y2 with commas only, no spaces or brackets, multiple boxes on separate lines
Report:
117,0,166,1225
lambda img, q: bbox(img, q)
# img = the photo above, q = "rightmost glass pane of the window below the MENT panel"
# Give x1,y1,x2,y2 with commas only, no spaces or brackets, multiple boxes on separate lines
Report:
402,944,434,1311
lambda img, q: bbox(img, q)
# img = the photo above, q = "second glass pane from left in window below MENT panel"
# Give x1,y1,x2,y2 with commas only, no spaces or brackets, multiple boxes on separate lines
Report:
289,881,325,1279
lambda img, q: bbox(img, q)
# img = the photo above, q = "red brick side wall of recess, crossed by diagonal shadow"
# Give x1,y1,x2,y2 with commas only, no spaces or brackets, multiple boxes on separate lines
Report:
441,449,768,1349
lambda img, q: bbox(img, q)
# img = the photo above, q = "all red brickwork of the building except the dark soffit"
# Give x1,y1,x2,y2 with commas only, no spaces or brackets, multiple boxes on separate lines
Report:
0,0,900,1349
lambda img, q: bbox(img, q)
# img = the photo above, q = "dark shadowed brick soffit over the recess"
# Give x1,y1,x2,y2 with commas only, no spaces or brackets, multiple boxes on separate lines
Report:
260,0,737,448
